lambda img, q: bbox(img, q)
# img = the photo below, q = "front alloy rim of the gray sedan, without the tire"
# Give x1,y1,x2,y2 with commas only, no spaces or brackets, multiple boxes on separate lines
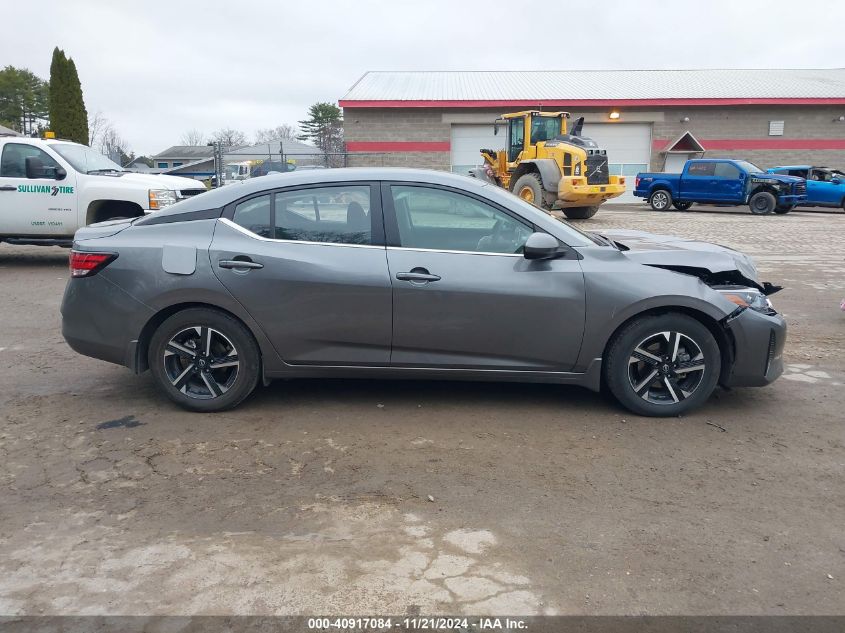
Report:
628,331,705,404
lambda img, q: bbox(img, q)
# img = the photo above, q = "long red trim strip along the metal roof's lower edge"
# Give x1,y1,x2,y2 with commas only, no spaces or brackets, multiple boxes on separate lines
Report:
339,97,845,108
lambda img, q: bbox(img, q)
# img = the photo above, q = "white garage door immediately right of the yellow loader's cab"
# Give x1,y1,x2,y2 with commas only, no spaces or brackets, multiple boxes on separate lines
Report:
583,123,651,204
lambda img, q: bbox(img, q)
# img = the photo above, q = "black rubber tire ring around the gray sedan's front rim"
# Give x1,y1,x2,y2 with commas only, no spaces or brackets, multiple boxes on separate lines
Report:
603,312,722,417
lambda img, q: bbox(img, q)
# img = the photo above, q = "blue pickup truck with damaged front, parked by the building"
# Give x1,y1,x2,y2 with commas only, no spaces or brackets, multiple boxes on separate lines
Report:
634,159,807,215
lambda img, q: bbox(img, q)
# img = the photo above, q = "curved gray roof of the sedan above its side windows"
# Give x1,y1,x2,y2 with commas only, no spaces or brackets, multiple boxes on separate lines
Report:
143,167,487,221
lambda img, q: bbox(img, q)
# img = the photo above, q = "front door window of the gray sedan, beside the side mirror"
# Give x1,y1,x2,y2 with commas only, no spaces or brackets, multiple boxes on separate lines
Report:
391,185,533,254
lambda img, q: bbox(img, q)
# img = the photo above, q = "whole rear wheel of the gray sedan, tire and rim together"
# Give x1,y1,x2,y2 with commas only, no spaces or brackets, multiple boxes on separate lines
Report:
148,308,261,412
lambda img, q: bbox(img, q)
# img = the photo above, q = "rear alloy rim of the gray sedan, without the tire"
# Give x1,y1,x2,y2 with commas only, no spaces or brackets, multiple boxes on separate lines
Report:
163,325,240,400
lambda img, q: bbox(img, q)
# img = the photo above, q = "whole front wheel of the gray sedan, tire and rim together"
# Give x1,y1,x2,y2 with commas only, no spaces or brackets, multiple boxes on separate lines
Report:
604,313,722,417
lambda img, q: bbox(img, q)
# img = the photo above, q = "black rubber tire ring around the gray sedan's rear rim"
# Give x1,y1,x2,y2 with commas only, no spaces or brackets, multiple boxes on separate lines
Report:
148,308,261,412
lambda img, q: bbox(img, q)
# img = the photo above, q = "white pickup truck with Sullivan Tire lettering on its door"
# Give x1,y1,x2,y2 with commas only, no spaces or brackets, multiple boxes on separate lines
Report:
0,136,206,246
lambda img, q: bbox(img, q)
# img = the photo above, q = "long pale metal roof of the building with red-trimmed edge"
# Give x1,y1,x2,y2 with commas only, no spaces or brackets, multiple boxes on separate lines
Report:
340,68,845,107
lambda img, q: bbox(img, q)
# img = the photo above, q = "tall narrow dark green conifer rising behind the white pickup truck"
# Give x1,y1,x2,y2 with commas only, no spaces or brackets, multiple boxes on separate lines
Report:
50,47,88,145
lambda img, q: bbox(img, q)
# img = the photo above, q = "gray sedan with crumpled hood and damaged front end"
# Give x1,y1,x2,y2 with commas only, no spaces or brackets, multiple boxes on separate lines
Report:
62,169,786,416
